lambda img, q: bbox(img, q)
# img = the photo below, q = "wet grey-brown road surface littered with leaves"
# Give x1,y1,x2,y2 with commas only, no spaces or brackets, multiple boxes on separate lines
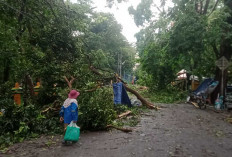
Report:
0,104,232,157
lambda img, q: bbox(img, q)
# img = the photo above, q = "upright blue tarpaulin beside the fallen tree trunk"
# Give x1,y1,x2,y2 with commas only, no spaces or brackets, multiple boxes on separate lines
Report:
113,82,132,107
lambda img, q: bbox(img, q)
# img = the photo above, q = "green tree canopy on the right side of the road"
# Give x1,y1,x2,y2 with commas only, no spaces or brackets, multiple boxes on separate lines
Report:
129,0,232,92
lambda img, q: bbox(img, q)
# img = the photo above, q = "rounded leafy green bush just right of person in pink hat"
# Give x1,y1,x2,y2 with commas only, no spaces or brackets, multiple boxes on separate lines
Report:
78,87,116,130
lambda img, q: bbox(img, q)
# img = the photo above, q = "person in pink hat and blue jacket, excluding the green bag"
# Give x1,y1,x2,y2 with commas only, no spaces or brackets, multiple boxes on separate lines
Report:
60,90,80,143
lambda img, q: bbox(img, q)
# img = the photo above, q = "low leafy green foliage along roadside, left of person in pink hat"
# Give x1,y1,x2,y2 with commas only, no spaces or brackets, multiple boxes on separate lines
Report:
0,99,62,149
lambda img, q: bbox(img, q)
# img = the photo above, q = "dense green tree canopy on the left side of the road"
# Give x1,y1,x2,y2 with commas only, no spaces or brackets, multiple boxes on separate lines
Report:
0,0,135,95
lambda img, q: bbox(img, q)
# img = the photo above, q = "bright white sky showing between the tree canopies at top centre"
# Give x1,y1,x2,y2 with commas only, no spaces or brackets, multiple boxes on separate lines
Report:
71,0,173,43
